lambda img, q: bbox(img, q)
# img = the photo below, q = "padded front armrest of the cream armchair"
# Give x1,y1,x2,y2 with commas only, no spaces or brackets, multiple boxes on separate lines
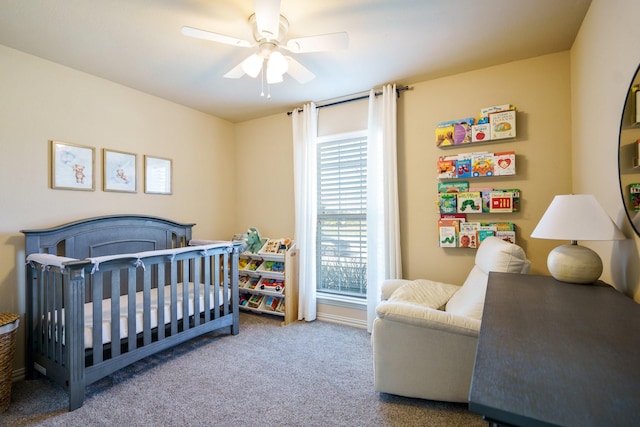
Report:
376,302,480,337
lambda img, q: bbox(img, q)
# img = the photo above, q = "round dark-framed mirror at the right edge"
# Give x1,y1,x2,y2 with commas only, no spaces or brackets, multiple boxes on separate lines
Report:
618,65,640,237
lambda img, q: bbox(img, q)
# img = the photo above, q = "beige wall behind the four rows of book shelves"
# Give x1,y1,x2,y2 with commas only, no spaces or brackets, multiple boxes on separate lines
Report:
398,52,571,283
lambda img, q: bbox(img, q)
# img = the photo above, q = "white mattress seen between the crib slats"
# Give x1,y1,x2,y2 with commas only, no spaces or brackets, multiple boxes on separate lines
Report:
54,283,231,349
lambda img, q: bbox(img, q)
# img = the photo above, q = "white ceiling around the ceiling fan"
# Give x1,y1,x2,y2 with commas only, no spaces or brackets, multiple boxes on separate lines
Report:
0,0,591,122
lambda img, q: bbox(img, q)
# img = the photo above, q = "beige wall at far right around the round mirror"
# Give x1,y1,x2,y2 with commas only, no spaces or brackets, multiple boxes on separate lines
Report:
571,0,640,302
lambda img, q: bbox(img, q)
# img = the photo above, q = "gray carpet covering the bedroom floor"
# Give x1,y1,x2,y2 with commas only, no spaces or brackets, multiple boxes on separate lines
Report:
0,313,486,426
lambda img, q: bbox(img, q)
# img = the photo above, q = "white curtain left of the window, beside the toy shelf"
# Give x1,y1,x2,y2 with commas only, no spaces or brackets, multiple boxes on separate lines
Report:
292,103,318,322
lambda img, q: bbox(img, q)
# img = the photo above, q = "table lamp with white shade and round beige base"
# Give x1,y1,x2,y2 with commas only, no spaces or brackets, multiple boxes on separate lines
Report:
531,194,625,283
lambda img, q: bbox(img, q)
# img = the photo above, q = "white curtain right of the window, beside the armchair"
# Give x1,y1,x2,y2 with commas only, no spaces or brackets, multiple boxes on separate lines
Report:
367,85,402,332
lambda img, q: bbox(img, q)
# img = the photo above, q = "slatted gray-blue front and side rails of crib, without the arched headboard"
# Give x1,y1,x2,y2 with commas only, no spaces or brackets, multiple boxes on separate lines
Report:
27,242,239,410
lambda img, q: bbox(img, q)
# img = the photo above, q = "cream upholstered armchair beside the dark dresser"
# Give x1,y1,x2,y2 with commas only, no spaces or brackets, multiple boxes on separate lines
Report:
371,237,530,402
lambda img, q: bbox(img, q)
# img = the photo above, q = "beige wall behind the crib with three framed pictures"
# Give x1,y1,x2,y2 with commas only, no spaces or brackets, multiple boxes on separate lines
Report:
0,46,236,374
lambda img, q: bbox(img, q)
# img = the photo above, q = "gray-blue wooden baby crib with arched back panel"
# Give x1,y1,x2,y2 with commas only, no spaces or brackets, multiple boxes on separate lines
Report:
22,215,240,411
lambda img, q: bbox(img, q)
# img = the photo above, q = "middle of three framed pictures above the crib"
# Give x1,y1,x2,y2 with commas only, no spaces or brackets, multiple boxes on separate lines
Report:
102,148,137,193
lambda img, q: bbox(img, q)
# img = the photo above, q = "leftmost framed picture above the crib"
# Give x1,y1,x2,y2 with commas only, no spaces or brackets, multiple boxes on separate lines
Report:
50,140,95,191
